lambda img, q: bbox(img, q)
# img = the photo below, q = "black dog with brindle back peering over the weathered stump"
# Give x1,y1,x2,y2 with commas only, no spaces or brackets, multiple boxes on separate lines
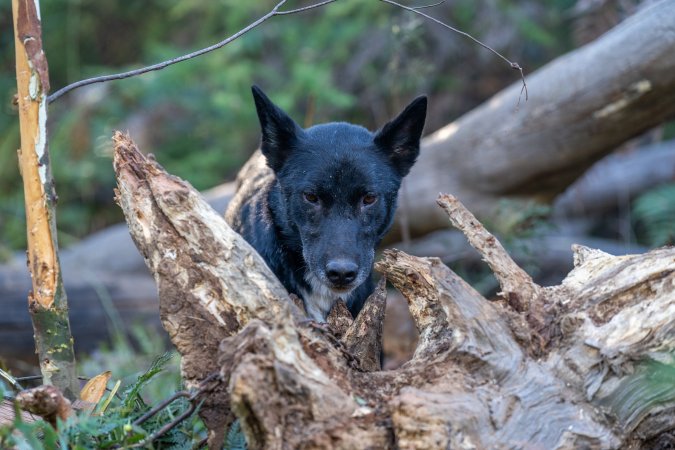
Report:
225,86,427,322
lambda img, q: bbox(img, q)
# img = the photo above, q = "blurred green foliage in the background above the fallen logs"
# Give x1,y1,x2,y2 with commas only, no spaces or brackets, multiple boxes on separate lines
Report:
0,0,570,253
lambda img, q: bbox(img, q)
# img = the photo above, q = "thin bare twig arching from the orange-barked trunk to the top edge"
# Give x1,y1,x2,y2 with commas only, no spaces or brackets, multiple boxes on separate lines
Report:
47,0,337,103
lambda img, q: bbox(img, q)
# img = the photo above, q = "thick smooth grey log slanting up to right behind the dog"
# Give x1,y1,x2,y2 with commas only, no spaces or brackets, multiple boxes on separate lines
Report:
390,0,675,242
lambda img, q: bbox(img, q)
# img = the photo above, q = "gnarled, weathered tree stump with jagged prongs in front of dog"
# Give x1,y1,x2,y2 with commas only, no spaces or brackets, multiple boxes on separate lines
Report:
114,134,675,449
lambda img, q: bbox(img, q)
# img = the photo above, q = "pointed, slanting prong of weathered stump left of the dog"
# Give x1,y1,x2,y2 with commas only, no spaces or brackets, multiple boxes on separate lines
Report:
113,132,299,445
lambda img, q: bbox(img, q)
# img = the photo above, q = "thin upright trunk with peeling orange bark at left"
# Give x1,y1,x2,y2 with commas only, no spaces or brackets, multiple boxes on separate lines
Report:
12,0,79,399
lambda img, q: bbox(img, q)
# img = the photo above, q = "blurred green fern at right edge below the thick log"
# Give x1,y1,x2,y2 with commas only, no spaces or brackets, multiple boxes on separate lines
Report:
633,184,675,247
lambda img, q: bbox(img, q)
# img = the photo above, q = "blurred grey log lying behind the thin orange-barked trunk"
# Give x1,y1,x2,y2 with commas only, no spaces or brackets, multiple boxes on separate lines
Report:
0,183,234,362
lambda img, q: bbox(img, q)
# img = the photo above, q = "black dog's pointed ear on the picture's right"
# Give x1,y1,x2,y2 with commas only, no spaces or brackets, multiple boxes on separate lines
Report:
374,96,427,177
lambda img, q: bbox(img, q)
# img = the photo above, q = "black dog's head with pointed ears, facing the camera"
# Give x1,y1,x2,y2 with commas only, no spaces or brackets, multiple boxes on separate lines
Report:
252,86,427,298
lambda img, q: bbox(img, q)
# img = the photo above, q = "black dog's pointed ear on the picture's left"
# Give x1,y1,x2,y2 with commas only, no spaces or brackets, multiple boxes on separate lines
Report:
251,85,303,172
